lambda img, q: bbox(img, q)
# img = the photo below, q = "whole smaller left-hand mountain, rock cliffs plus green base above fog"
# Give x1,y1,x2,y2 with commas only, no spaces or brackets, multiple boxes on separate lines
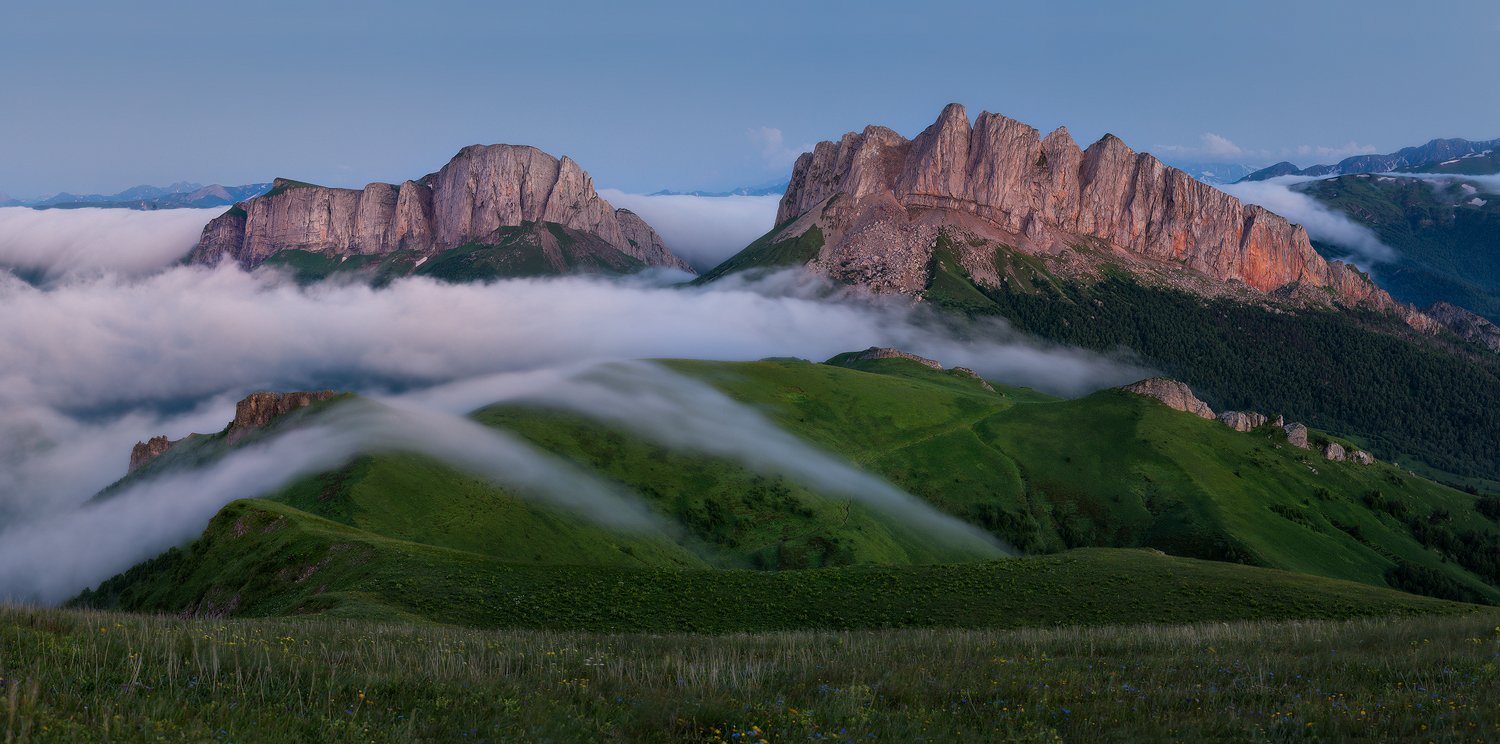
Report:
189,144,690,278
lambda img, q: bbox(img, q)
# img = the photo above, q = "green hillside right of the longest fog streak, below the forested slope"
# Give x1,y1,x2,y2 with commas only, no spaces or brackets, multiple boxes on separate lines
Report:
678,360,1500,600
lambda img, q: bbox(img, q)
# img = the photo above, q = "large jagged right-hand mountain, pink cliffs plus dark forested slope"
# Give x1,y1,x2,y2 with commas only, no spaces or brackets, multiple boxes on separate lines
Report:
699,107,1500,482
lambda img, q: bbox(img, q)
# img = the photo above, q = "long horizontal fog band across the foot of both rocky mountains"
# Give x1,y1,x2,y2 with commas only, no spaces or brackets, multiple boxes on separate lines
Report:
0,264,1142,411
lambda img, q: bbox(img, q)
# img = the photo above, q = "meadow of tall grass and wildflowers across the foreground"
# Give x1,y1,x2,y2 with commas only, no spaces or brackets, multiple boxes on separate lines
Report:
0,608,1500,743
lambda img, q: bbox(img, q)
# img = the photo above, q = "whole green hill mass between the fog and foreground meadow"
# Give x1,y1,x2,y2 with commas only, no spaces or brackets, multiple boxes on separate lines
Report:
81,354,1500,621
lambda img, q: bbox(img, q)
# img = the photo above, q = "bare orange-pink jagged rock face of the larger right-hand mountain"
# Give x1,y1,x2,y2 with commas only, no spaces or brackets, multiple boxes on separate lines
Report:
777,104,1431,327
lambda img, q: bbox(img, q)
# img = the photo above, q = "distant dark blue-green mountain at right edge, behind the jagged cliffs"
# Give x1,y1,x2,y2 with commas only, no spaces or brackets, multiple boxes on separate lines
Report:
1290,171,1500,321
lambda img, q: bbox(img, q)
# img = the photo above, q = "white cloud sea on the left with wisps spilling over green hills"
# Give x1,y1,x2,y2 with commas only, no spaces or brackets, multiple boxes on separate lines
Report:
0,197,1149,602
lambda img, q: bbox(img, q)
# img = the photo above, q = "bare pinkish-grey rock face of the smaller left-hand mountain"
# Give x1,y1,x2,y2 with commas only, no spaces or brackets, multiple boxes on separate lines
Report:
191,144,687,270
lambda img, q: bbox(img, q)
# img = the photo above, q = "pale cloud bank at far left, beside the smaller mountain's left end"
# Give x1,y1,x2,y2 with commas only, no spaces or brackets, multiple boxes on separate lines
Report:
0,207,224,282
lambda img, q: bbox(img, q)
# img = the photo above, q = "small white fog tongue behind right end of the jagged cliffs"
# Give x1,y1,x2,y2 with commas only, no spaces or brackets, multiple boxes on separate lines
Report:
1218,176,1397,272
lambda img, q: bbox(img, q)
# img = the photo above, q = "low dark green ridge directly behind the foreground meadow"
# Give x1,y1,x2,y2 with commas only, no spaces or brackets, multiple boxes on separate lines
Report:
70,500,1473,633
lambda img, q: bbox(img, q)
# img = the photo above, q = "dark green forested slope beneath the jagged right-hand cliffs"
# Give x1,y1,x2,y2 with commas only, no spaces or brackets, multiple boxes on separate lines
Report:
701,232,1500,489
